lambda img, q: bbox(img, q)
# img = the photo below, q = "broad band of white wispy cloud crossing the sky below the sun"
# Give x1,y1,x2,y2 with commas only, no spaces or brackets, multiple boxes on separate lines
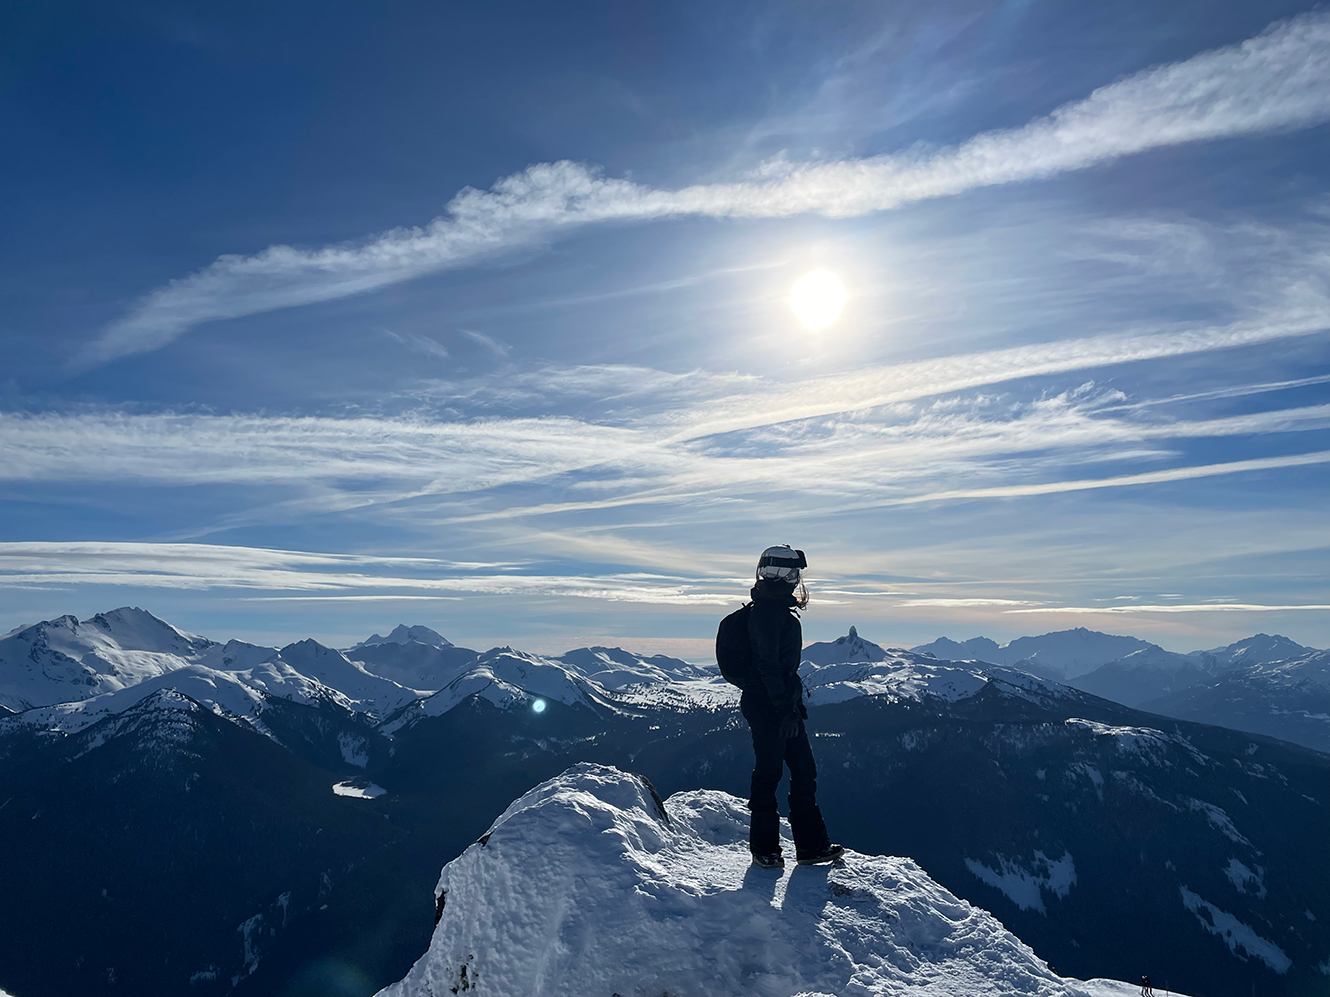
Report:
0,374,1330,555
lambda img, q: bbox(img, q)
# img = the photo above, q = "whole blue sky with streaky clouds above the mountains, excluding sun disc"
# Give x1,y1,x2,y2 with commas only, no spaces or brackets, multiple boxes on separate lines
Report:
0,0,1330,657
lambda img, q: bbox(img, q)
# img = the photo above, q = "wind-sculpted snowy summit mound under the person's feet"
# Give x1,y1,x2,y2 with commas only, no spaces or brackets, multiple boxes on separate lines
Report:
380,763,1149,997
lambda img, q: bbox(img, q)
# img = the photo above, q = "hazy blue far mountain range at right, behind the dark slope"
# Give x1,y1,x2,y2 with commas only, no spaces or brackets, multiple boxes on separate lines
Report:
912,627,1330,751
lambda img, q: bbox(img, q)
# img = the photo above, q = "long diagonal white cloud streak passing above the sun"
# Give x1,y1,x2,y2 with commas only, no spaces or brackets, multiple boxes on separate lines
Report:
74,13,1330,367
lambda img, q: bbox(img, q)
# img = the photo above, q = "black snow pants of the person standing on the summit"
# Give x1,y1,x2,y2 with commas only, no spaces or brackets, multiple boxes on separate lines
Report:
739,695,830,857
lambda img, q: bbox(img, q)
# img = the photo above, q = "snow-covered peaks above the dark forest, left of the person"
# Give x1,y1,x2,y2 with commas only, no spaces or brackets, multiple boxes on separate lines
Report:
0,609,726,734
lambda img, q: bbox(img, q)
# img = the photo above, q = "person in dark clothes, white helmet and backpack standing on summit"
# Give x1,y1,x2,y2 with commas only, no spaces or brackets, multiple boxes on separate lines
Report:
716,545,845,868
